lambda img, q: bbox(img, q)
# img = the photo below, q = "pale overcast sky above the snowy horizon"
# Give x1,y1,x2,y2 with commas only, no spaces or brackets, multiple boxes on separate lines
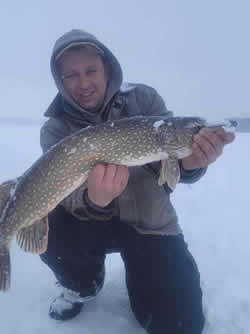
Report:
0,0,250,119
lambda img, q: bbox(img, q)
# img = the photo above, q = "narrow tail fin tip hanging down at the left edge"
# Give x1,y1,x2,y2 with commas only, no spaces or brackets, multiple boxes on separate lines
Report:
0,247,11,291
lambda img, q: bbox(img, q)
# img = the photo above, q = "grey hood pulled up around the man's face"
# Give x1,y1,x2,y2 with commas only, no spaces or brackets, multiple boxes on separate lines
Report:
44,30,122,123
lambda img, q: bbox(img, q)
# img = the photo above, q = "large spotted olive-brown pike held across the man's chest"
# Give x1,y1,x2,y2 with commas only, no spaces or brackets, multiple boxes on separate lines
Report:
0,117,221,291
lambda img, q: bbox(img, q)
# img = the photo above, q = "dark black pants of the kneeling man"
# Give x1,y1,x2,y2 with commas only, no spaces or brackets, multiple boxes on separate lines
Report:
41,206,204,334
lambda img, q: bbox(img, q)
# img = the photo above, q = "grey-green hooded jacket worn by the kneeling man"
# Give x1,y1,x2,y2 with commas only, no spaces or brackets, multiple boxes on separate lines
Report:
41,30,205,235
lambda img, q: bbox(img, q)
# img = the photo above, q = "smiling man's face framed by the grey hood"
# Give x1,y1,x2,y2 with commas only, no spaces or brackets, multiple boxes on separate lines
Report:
58,48,108,110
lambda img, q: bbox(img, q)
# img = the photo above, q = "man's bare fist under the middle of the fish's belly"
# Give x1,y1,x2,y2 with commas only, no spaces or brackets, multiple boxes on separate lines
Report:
88,164,129,207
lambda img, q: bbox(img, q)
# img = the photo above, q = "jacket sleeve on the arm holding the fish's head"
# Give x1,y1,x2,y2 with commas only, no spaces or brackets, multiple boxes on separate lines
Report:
134,85,207,184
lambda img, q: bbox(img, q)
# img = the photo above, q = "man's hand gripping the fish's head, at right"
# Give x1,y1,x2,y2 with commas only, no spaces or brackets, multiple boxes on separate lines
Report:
182,129,235,170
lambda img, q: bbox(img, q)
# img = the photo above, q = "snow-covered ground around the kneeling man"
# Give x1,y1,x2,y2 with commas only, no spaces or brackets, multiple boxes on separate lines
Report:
0,123,250,334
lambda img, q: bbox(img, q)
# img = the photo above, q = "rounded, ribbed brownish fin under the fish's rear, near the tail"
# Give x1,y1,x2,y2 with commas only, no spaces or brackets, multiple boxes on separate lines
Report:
16,216,49,254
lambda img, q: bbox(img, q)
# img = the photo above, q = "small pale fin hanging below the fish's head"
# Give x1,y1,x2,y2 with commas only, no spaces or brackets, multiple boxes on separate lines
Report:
158,157,180,190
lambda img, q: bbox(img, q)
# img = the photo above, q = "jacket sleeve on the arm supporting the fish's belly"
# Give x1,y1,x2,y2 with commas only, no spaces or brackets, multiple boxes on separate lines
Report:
40,119,116,221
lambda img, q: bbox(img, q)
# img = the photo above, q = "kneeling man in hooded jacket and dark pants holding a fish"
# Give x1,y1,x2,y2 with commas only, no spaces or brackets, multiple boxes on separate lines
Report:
41,30,233,334
